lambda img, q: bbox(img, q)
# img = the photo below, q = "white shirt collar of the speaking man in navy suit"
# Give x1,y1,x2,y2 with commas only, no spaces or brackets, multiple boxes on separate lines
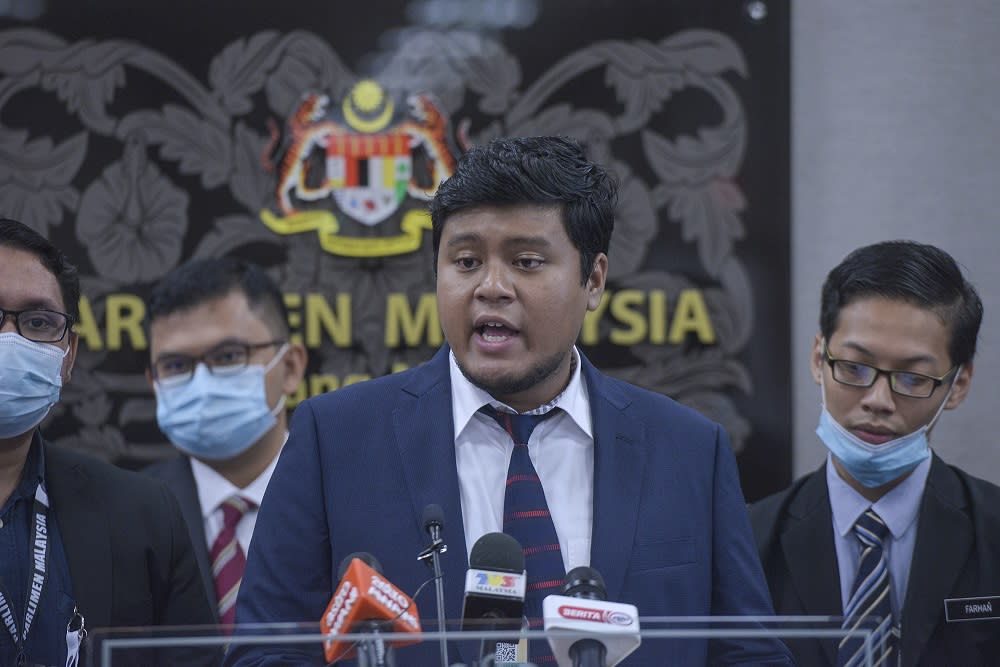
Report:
448,346,594,439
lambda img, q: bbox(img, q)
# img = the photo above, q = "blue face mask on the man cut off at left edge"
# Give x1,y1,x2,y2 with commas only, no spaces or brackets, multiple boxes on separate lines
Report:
0,331,69,438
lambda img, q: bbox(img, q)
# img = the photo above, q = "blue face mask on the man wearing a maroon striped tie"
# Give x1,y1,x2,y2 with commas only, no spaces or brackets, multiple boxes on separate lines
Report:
154,343,288,461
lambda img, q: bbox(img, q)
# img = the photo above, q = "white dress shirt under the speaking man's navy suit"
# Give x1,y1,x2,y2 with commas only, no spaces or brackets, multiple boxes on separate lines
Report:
450,348,594,572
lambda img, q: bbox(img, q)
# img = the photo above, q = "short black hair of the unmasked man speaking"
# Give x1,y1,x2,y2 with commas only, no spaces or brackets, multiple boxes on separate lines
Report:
430,137,618,283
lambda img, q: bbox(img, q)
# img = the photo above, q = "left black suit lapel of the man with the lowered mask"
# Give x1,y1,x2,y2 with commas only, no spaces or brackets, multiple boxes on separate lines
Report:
781,468,843,664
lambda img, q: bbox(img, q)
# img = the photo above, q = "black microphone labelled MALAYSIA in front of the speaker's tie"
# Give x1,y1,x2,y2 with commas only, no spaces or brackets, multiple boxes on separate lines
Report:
462,533,527,658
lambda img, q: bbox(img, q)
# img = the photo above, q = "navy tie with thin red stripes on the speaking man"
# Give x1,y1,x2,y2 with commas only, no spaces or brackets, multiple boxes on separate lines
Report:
482,406,566,663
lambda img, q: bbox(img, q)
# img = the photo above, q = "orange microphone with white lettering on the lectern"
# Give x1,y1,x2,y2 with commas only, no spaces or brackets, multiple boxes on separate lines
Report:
319,552,420,667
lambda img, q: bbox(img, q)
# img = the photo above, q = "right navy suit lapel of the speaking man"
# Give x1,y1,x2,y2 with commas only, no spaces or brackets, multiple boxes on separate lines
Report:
580,354,646,600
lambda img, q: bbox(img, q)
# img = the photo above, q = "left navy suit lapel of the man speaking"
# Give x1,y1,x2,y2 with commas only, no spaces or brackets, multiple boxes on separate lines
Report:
392,347,469,636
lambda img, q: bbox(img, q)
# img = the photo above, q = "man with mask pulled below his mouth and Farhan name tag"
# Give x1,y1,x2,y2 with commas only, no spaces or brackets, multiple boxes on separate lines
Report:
750,241,1000,666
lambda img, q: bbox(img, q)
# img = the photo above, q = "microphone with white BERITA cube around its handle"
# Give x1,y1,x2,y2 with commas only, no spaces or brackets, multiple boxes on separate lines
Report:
542,566,642,667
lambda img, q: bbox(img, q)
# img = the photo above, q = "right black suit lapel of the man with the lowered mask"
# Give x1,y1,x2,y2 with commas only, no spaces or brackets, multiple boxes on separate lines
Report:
902,455,973,663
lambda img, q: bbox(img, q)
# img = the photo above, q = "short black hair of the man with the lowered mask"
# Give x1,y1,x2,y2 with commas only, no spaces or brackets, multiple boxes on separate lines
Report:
819,241,983,364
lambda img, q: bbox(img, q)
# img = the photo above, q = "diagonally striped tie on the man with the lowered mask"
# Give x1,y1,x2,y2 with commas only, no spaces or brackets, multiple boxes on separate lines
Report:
837,508,897,667
